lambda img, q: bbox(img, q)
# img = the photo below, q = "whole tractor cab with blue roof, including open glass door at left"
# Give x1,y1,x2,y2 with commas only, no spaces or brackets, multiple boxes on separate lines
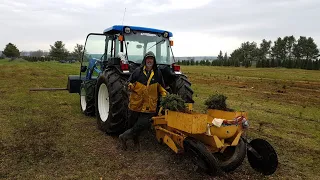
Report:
81,25,180,80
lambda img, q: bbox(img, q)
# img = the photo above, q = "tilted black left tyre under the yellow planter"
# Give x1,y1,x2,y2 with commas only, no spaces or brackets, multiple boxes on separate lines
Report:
183,138,220,175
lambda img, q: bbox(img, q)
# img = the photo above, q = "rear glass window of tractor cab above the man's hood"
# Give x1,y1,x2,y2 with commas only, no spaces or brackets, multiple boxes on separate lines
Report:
124,31,172,64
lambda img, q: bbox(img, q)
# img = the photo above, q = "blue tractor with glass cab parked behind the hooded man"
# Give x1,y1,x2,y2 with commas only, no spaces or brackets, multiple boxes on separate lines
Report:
68,25,194,134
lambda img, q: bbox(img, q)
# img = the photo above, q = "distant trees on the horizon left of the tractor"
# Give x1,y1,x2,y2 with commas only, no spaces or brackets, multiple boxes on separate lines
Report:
0,41,84,62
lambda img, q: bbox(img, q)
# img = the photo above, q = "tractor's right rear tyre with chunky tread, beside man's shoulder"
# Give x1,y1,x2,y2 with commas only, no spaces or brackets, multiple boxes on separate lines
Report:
170,74,194,103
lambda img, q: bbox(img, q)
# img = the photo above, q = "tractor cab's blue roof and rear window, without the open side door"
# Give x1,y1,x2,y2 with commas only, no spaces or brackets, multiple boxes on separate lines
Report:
104,26,173,64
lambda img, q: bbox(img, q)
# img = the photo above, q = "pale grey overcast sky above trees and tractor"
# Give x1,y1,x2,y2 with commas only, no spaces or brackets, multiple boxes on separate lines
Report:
0,0,320,56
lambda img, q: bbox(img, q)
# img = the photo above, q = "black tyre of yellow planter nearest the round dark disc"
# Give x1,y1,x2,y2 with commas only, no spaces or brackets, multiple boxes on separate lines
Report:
213,138,247,172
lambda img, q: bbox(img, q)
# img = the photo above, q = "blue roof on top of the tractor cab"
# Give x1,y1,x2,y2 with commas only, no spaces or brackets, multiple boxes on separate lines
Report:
103,25,172,37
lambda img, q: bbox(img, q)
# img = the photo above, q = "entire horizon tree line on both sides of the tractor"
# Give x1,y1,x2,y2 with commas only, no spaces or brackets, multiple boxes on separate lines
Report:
0,36,320,70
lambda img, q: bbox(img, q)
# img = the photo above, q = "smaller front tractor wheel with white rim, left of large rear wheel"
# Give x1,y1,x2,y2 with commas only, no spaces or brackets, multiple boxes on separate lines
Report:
80,80,96,116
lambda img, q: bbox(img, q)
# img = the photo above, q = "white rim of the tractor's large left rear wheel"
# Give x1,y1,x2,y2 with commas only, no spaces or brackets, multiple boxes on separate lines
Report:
98,83,109,122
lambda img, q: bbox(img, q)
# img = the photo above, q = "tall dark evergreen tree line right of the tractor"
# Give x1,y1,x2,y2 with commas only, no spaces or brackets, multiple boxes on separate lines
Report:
178,36,320,70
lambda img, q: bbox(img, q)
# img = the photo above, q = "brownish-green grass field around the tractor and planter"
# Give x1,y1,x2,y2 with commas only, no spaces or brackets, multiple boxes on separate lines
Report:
0,60,320,179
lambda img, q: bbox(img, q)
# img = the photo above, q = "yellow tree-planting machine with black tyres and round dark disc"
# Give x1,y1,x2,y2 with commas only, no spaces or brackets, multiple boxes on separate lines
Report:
152,104,278,175
